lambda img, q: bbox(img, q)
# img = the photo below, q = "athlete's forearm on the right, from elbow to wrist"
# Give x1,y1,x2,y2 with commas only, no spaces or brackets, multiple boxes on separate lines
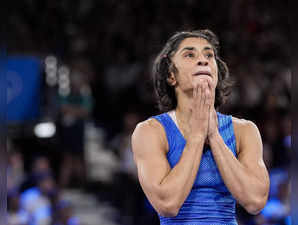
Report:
209,132,267,213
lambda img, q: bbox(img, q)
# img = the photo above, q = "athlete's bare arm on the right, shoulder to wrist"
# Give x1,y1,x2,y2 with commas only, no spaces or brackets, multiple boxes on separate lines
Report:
209,114,269,214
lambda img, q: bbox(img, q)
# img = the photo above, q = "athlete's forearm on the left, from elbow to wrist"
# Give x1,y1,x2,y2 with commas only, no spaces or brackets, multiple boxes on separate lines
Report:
160,138,204,211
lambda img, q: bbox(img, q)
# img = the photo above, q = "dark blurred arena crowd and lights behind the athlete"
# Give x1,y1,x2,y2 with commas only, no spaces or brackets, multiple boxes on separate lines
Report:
4,0,291,225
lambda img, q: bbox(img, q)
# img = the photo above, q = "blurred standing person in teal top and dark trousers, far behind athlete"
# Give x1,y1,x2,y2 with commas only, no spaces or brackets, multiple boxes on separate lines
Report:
59,71,93,188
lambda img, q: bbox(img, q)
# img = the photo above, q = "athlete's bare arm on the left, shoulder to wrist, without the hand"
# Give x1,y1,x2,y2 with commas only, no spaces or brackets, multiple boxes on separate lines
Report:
132,120,204,217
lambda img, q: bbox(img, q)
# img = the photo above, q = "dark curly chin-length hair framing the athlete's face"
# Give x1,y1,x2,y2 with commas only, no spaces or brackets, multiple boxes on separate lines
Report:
152,29,233,112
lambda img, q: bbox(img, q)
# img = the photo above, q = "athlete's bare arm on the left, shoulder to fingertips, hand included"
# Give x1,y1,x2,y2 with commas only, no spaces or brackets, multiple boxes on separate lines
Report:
132,83,211,217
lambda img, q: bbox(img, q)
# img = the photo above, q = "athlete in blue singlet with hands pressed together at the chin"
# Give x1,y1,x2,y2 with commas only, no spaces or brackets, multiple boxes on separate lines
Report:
131,30,269,225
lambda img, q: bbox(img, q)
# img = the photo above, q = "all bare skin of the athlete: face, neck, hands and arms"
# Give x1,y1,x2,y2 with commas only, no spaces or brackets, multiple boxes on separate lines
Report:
132,38,269,217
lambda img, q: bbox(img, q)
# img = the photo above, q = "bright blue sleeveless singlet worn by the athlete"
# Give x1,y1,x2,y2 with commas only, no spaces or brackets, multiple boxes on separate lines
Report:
153,112,237,225
